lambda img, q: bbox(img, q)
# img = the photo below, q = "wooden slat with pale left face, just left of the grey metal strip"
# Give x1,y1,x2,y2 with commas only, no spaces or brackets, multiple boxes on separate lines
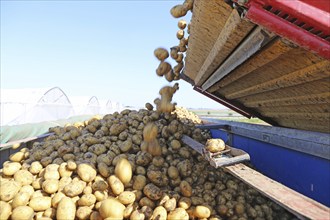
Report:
195,10,255,86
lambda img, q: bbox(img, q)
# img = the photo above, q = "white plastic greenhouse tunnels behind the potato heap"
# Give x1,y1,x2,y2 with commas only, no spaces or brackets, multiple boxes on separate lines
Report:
0,87,124,144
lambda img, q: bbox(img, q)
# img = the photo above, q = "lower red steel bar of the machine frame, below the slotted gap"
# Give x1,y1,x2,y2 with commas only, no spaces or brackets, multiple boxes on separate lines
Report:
246,2,330,60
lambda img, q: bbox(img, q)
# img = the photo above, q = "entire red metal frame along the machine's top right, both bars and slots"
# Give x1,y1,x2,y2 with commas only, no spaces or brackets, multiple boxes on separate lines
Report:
234,0,330,60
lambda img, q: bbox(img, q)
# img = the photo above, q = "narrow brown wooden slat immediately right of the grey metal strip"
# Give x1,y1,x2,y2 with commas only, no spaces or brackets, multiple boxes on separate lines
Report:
208,40,292,92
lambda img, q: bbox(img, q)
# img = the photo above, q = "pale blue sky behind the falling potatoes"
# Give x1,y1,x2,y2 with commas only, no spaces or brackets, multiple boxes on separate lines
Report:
0,0,224,109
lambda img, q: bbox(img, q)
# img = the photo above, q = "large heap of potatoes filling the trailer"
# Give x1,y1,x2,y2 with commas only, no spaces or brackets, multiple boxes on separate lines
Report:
0,108,291,220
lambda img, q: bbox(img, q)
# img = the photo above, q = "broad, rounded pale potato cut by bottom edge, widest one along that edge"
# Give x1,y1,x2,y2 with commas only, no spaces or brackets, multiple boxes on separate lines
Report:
99,198,126,219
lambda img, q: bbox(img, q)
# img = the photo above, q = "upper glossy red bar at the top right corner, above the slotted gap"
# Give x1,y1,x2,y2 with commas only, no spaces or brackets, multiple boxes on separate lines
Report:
246,0,330,35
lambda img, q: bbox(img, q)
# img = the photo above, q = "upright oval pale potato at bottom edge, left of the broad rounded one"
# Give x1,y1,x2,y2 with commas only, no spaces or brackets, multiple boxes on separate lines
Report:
56,197,76,220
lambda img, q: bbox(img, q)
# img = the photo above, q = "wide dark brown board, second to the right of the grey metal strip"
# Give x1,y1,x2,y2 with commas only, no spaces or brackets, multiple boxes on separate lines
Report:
221,45,323,94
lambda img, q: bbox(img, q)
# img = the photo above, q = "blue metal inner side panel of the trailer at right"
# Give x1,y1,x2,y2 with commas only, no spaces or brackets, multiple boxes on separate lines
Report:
211,129,330,207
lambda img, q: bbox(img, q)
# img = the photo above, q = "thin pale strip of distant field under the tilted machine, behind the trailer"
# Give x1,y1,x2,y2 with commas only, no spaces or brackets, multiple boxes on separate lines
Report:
189,109,267,125
